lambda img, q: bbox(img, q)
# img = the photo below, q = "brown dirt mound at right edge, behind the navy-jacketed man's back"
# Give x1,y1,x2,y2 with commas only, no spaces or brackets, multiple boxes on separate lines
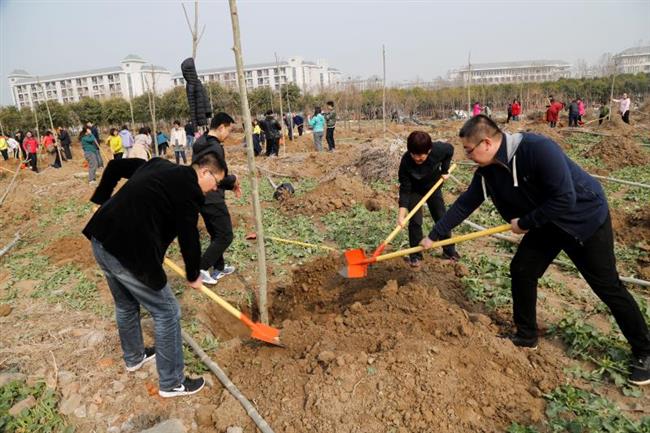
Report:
584,136,650,170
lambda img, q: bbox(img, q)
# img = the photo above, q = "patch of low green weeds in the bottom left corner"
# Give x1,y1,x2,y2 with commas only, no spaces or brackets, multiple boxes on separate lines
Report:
0,380,75,433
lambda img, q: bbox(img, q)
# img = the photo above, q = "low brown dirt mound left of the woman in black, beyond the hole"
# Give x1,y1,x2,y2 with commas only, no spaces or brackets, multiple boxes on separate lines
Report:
280,175,388,215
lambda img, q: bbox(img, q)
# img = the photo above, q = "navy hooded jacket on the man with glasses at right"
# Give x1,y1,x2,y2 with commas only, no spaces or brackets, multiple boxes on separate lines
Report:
429,133,609,242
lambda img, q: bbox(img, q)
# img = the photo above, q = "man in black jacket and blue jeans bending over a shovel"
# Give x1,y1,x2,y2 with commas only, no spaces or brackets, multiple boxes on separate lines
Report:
83,151,225,397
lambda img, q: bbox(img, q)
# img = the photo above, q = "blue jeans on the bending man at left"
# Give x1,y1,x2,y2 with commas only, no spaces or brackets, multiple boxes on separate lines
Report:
91,238,185,390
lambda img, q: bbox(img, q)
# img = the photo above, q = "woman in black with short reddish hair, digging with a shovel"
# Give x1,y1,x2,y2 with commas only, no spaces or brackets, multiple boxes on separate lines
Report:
397,131,460,268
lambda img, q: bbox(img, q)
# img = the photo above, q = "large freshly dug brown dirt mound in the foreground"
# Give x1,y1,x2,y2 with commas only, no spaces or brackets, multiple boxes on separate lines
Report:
214,257,562,433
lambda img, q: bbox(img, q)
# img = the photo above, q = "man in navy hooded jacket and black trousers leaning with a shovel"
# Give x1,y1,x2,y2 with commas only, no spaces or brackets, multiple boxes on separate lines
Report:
421,115,650,385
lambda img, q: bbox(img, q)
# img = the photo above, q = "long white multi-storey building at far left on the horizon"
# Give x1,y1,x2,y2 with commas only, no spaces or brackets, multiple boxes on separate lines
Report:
9,54,172,108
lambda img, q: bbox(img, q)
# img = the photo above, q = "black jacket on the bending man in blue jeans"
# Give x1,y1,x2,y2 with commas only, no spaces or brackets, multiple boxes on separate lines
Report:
83,158,204,290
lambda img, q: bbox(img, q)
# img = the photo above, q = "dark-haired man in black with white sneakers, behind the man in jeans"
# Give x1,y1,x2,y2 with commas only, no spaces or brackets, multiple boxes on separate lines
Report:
192,113,241,284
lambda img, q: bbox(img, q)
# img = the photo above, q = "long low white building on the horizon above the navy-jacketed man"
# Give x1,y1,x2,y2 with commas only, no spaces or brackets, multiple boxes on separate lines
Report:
449,60,571,84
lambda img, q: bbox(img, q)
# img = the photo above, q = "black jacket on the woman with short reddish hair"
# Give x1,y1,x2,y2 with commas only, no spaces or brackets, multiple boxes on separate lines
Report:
398,141,454,208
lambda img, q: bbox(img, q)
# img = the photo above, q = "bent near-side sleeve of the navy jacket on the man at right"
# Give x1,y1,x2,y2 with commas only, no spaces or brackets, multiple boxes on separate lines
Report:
519,140,576,230
